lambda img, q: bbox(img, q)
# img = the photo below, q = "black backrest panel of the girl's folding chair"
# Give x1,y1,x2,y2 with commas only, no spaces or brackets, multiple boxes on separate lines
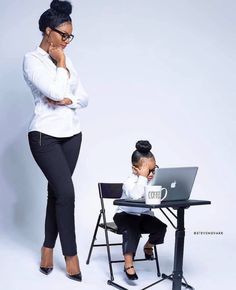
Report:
98,183,123,199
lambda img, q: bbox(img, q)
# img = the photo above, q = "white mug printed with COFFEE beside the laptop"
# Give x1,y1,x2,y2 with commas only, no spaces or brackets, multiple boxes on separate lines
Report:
145,185,167,204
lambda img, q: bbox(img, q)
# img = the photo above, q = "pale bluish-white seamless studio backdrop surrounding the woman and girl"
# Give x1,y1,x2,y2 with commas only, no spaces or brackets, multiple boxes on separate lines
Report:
0,0,236,290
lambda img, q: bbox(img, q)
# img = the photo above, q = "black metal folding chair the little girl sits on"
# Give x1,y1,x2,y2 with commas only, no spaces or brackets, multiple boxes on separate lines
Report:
86,183,160,289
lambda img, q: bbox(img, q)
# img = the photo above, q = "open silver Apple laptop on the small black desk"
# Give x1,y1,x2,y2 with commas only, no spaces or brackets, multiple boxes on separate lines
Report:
151,167,198,201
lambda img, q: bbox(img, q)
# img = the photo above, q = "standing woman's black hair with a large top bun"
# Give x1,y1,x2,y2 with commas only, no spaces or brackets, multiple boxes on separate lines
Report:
39,0,72,33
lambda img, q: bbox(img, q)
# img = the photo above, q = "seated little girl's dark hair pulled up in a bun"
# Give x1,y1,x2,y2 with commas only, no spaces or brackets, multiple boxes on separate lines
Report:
131,140,154,165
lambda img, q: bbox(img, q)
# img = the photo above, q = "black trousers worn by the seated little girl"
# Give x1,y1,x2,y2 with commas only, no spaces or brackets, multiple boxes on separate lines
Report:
114,212,166,255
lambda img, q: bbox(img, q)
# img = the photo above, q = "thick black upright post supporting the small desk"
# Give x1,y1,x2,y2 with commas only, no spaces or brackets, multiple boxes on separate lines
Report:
172,208,185,290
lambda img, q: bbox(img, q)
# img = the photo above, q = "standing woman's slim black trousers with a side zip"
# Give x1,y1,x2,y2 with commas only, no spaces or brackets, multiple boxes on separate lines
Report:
28,131,82,256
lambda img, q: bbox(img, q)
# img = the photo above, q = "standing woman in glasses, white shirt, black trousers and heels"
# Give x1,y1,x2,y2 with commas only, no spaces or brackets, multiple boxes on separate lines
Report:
23,0,88,281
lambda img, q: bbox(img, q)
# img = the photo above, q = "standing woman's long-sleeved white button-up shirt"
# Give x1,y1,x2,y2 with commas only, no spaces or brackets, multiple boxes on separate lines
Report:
23,47,88,137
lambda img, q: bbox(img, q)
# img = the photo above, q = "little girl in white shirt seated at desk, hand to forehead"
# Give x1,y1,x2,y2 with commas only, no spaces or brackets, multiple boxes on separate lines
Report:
114,141,166,280
